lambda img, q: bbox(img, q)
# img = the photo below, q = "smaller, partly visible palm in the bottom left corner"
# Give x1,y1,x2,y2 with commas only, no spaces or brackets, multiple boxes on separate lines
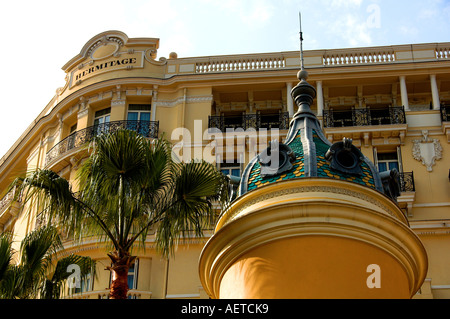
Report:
0,226,95,299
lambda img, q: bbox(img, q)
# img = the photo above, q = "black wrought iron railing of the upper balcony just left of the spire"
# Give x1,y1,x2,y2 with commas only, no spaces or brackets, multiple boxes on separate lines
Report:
208,112,289,132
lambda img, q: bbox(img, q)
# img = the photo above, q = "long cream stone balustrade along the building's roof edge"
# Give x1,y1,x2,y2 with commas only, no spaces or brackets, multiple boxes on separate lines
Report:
167,42,450,76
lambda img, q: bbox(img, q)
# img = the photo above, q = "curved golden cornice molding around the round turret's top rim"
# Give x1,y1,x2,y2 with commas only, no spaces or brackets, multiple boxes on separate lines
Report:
199,178,427,296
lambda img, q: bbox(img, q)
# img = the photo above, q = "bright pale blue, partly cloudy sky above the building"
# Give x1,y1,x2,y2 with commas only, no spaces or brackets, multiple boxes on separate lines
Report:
0,0,450,157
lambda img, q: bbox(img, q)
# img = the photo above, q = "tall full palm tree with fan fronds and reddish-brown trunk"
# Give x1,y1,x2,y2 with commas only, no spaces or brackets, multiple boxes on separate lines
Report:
15,129,228,299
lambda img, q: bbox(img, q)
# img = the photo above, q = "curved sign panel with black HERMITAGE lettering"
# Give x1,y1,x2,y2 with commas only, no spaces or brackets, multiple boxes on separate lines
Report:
69,52,144,88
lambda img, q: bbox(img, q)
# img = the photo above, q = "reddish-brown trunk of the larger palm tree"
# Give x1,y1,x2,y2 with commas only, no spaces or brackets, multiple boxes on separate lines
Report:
106,250,136,299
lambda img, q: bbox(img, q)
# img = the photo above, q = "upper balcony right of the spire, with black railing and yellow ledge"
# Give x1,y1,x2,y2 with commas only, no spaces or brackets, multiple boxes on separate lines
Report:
323,106,407,147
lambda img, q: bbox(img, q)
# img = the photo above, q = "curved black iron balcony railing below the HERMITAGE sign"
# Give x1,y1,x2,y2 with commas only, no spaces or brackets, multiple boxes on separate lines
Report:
45,121,159,165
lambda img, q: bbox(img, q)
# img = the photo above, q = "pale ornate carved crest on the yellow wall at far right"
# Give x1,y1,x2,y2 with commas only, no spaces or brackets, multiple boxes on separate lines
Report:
412,130,442,172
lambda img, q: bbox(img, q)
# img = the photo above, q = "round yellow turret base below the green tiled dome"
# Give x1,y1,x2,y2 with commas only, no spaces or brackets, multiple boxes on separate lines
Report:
199,178,427,298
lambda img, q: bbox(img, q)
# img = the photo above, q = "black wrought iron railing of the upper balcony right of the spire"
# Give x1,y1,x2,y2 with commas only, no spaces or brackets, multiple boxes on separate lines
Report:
323,106,406,127
